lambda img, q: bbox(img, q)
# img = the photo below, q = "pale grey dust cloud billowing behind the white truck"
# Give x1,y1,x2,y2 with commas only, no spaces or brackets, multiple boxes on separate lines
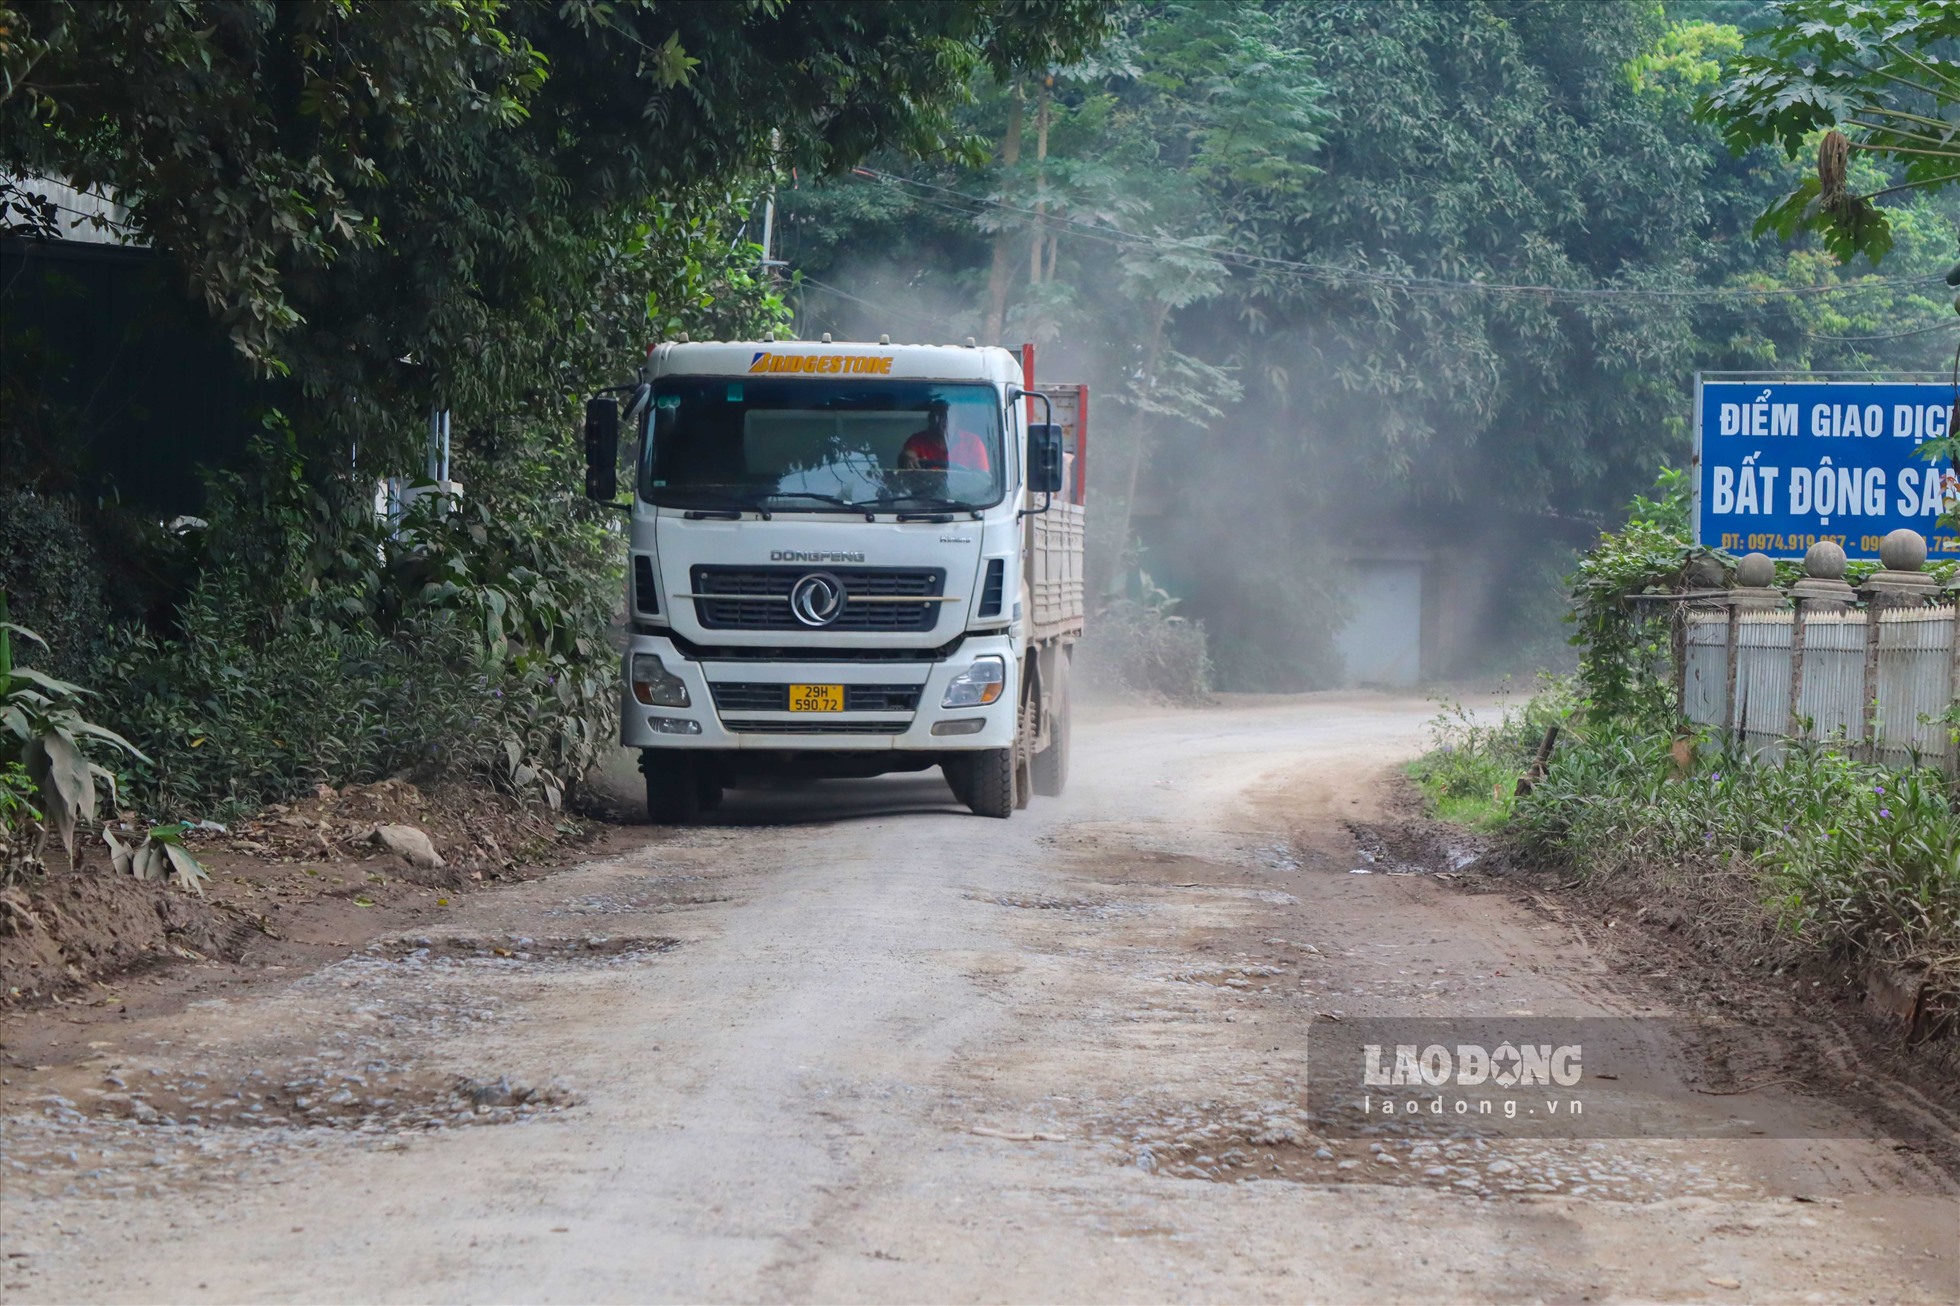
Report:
794,257,1590,698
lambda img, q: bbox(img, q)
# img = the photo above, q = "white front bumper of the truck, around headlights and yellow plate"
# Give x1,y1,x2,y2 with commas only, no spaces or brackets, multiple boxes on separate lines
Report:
619,635,1019,753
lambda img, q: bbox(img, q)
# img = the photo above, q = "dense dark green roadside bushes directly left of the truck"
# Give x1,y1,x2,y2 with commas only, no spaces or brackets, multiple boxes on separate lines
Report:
106,445,619,816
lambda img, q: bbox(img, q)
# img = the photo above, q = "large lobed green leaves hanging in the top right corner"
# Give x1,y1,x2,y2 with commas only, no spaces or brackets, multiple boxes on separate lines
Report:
1703,0,1960,263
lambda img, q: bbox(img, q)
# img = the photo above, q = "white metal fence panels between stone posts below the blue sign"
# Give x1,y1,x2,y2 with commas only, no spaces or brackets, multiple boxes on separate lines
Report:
1680,606,1960,775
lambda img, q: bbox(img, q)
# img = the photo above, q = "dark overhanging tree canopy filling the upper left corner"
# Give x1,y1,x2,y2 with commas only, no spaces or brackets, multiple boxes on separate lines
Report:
0,0,1102,468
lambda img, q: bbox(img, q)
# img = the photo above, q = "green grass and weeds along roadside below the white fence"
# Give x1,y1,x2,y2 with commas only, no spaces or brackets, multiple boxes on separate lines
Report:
1409,682,1960,1010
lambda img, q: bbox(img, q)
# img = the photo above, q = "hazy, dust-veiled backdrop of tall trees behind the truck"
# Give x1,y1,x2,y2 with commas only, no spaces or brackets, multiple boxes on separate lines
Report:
774,0,1960,690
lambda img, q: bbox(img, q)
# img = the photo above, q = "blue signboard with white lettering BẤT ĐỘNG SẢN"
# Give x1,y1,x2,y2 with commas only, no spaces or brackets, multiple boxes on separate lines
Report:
1695,378,1960,559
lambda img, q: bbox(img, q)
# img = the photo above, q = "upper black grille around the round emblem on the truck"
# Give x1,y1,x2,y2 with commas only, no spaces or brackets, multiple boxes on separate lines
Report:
690,567,947,631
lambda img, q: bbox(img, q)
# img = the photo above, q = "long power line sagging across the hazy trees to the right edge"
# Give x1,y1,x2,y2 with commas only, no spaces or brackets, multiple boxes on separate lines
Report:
853,167,1938,300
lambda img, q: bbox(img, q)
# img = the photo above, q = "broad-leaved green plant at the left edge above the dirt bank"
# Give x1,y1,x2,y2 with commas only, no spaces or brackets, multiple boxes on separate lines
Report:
0,596,149,865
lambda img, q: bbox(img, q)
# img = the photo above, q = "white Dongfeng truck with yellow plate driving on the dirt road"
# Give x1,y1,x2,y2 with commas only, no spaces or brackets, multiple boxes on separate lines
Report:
586,337,1088,824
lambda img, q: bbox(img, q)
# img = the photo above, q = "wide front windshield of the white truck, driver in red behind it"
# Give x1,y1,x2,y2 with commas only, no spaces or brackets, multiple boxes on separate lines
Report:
639,377,1005,512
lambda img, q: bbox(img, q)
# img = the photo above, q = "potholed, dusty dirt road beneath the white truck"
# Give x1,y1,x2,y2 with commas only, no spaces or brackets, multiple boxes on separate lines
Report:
0,696,1960,1302
